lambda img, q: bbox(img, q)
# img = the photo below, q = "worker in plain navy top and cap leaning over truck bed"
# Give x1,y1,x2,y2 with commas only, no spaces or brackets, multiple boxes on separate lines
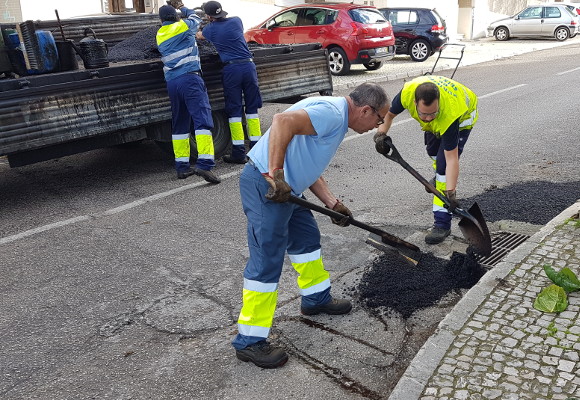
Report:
197,1,262,164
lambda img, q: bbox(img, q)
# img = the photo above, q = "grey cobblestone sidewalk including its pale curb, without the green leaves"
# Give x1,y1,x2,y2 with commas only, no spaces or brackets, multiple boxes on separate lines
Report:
389,201,580,400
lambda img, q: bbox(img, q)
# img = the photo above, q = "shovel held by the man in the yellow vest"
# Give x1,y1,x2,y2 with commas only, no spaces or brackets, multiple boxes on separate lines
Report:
376,136,491,257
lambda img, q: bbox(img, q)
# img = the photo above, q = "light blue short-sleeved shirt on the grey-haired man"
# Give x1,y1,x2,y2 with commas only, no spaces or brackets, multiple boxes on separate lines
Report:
248,96,348,195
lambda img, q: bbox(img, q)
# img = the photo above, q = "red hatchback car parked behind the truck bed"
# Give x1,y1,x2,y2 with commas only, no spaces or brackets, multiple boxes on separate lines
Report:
244,3,395,75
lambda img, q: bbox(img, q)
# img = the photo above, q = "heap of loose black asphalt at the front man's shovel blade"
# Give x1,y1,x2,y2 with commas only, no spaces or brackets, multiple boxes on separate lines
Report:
357,252,486,319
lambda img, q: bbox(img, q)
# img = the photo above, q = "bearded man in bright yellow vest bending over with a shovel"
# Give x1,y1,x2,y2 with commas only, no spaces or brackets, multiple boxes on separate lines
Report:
375,75,478,244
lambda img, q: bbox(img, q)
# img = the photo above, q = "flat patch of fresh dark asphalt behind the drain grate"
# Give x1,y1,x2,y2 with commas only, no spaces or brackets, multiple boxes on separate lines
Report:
461,181,580,225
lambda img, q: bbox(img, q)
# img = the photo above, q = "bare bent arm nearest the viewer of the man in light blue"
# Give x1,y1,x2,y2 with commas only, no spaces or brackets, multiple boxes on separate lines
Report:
268,110,316,176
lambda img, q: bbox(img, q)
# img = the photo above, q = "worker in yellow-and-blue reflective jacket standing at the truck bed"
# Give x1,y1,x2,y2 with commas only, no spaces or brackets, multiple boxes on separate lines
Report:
157,5,220,183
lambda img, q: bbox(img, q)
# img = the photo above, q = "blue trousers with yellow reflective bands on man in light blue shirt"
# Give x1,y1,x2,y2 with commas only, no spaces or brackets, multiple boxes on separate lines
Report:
232,164,330,349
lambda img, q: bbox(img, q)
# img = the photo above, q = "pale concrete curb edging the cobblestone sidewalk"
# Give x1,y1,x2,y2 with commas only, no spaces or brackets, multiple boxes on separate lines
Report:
388,200,580,400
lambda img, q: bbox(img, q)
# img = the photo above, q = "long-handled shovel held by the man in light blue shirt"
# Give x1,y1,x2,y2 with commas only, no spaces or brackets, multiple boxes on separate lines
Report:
288,196,421,265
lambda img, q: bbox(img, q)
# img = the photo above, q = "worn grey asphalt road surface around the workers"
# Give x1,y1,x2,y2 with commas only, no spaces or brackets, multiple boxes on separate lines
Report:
0,44,580,399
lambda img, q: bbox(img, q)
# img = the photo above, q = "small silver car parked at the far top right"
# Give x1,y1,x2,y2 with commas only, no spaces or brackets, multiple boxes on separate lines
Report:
487,5,578,41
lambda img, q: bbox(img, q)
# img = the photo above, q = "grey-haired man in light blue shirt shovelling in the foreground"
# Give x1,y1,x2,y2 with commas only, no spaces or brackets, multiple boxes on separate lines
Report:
232,83,390,368
